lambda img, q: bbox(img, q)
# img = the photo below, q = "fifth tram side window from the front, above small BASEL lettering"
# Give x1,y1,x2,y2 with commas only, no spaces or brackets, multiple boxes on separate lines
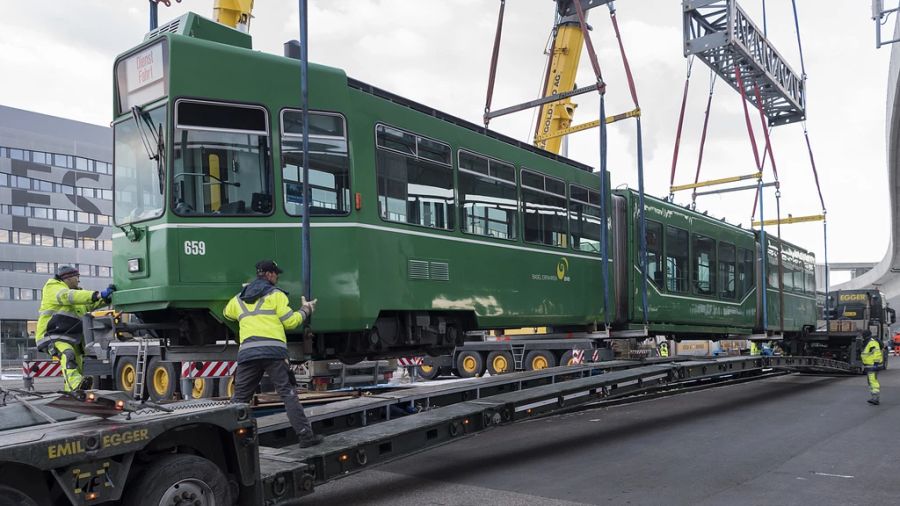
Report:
522,169,568,248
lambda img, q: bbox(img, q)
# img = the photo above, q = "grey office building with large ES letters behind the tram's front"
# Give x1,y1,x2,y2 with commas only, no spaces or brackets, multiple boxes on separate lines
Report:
0,105,113,362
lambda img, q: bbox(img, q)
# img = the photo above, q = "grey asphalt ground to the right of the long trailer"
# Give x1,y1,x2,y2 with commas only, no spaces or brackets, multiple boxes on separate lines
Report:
303,370,900,506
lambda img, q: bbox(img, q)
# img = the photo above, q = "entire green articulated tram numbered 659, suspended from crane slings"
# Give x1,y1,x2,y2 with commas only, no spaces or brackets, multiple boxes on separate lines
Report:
113,13,815,361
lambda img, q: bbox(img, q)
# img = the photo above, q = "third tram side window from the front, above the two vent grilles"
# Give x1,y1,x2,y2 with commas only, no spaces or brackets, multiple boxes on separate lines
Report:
375,125,454,230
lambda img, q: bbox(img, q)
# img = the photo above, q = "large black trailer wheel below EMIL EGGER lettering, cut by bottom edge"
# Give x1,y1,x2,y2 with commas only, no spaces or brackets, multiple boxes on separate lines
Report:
122,454,231,506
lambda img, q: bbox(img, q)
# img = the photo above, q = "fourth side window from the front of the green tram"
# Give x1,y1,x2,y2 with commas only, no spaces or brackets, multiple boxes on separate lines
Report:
458,151,519,239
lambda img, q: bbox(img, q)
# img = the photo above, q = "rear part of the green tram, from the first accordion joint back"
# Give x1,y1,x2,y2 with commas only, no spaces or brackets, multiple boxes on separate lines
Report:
610,190,816,339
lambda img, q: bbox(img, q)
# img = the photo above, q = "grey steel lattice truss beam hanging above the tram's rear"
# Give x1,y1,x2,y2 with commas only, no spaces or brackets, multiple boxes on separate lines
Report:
682,0,806,126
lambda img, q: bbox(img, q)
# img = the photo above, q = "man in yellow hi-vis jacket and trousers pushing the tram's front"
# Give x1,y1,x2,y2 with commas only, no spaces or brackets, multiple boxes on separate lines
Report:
34,265,116,392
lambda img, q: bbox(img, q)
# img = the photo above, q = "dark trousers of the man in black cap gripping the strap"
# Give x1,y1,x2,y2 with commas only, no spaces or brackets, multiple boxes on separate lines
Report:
231,359,312,438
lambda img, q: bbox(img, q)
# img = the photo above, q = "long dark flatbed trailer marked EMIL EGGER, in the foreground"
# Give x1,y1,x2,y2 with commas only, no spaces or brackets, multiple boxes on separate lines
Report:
0,356,849,506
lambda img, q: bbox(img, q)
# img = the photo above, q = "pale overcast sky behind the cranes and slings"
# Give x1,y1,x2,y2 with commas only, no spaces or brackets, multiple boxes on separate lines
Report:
0,0,890,272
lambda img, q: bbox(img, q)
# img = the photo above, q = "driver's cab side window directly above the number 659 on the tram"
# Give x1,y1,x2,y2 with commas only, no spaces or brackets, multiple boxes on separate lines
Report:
172,100,273,216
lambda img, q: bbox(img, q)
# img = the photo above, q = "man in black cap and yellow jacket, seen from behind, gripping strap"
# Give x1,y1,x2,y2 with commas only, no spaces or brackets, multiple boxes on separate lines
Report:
223,260,324,448
